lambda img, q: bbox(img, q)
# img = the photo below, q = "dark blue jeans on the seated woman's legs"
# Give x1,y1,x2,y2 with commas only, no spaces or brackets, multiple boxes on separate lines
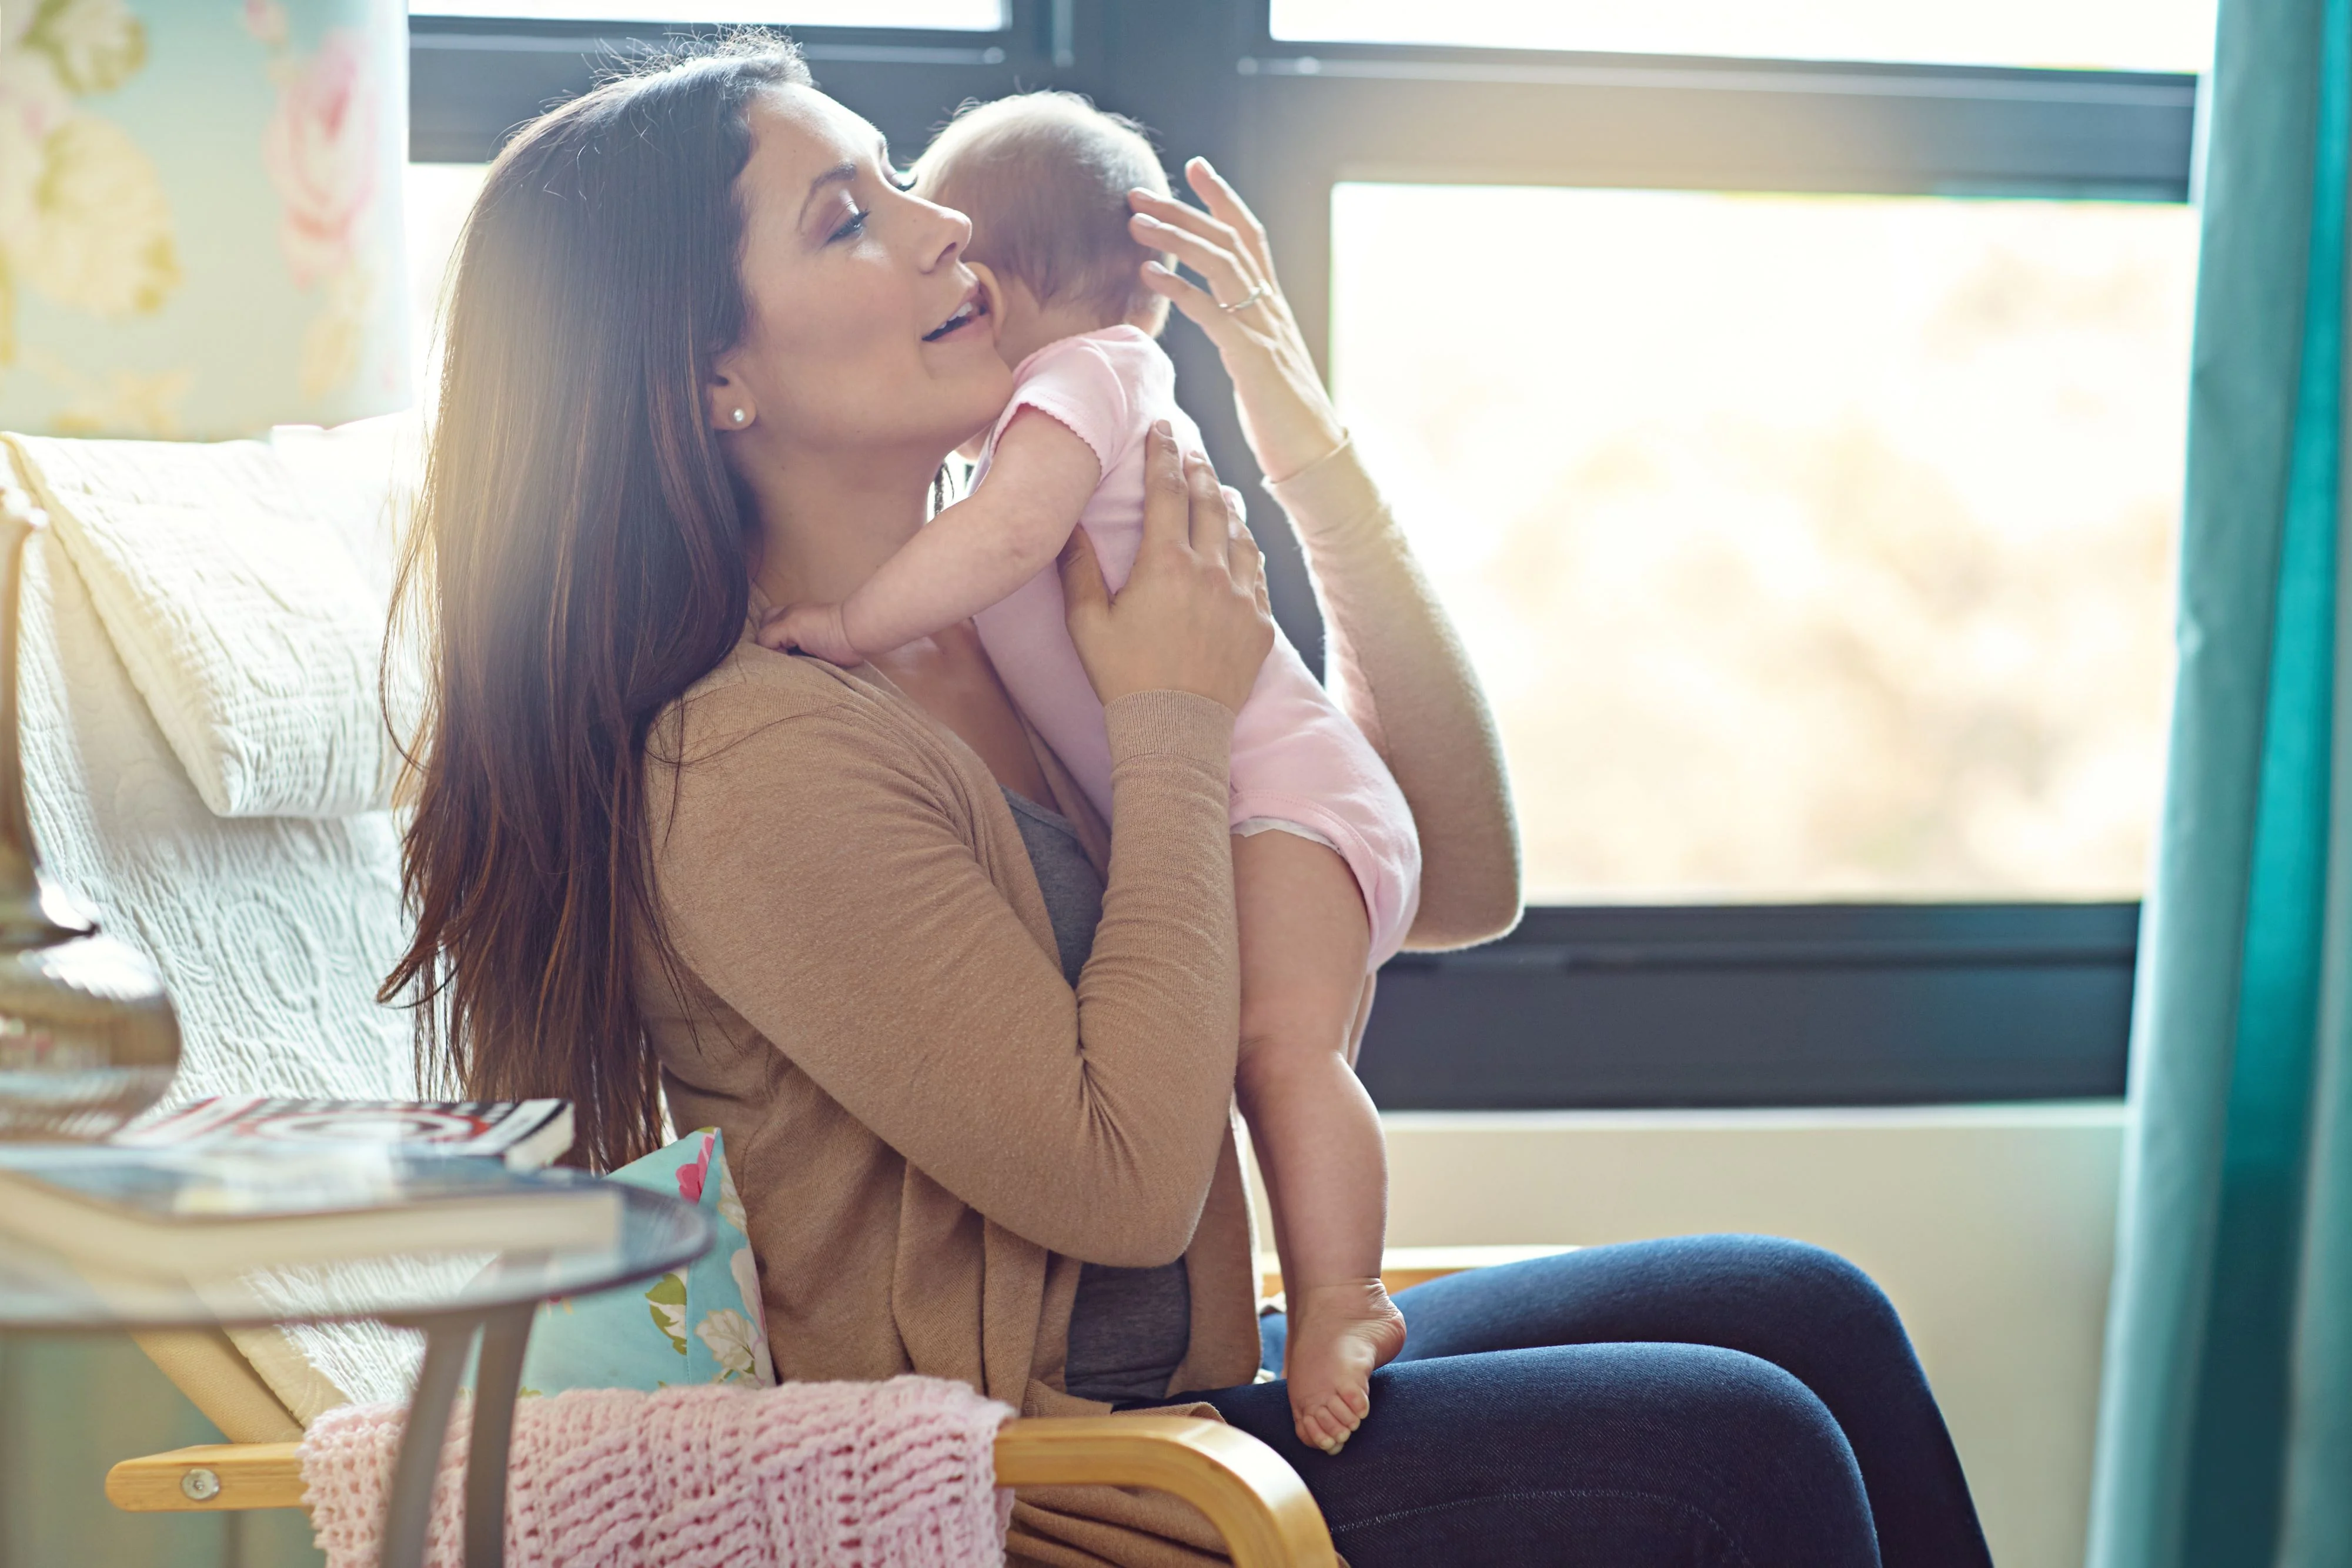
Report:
1192,1236,1992,1568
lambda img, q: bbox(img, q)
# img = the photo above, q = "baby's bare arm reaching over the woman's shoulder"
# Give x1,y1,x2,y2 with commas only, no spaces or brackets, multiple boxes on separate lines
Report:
760,409,1103,666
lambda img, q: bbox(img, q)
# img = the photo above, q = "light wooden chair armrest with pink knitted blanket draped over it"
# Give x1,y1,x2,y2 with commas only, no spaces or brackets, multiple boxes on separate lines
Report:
106,1415,1334,1568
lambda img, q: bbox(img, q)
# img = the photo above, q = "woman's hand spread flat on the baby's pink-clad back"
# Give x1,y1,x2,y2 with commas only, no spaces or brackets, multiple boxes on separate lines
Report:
1061,421,1275,710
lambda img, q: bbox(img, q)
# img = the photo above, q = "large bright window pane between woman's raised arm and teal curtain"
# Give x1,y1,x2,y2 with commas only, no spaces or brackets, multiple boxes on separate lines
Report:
1331,183,2197,902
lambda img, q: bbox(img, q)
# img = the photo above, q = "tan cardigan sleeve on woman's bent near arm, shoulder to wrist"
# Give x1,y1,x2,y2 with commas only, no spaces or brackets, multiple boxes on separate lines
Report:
656,691,1240,1267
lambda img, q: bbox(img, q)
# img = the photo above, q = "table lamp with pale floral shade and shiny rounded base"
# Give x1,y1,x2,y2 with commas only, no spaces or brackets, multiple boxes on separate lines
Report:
0,0,409,1140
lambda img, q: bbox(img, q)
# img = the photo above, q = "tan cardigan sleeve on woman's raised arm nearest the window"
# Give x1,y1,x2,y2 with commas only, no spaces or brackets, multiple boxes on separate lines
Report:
1265,442,1519,950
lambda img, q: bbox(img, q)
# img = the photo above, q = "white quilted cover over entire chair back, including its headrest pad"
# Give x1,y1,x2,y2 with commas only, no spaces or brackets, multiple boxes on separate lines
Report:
0,425,416,1417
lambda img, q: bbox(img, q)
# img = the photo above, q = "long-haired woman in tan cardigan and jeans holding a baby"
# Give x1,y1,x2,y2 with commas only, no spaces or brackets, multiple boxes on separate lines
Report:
388,45,1985,1568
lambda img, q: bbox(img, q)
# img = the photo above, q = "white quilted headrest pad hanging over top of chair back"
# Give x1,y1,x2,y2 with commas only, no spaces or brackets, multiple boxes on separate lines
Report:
9,435,397,815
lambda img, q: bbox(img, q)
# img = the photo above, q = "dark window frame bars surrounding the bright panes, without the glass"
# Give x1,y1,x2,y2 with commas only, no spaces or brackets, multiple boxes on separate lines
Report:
409,0,2164,1109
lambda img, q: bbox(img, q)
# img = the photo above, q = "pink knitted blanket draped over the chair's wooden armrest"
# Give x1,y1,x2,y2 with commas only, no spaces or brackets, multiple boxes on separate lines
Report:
301,1378,1011,1568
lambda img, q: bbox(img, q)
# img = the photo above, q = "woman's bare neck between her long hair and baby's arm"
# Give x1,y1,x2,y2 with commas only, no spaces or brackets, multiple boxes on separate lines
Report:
746,454,936,607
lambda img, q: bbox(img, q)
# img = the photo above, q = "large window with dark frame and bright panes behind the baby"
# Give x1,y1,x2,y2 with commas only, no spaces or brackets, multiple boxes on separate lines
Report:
412,0,2164,1109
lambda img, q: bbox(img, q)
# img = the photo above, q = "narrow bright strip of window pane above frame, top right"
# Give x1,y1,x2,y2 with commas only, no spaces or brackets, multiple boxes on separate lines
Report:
1272,0,2213,71
